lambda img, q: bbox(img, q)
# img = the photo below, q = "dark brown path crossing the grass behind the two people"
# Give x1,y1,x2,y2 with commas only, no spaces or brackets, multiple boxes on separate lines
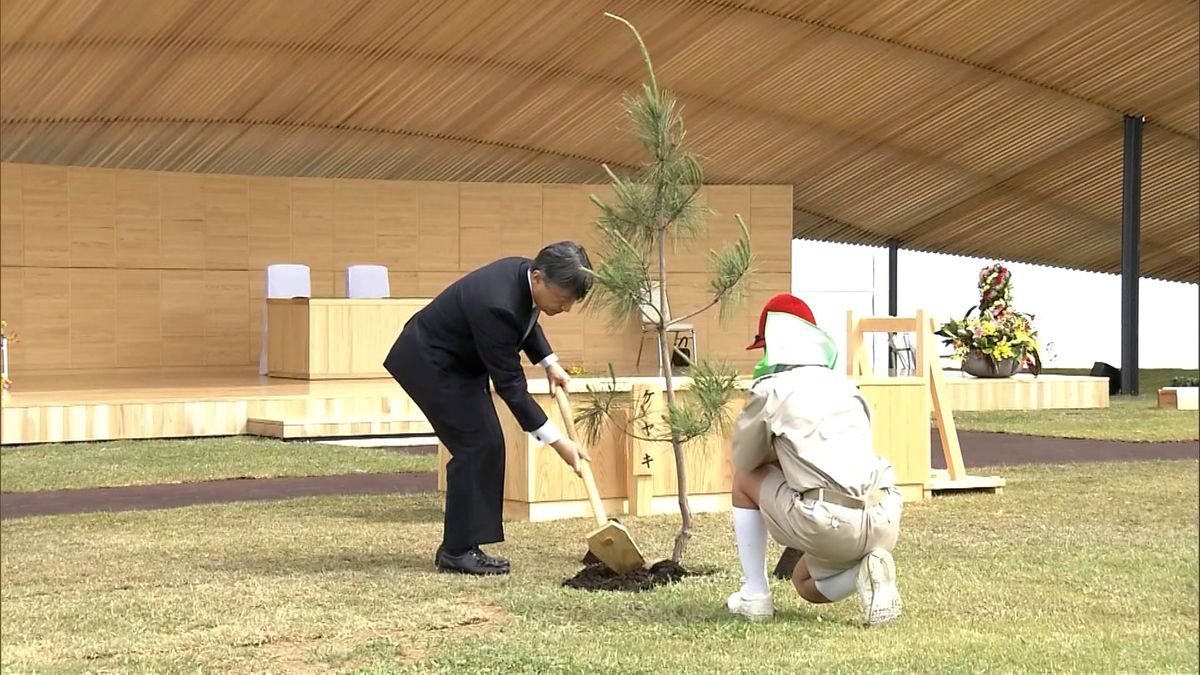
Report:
0,430,1200,519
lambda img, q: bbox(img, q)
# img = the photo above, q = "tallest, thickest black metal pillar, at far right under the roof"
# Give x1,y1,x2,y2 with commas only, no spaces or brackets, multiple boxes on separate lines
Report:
1121,115,1146,396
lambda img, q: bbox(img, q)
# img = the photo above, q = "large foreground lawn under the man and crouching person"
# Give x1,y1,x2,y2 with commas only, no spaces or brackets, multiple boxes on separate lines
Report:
0,461,1200,673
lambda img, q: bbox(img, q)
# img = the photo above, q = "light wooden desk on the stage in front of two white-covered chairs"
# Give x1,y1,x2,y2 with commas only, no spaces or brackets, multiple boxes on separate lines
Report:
266,298,430,380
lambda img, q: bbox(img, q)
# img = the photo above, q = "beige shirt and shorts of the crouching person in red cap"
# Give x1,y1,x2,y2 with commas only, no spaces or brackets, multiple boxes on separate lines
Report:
732,366,901,579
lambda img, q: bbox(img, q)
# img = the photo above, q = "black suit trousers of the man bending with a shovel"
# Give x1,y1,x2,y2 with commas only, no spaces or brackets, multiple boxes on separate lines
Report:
384,321,504,550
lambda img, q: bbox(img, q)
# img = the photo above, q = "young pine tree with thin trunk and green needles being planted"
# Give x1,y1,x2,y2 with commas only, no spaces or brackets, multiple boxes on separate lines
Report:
577,13,755,562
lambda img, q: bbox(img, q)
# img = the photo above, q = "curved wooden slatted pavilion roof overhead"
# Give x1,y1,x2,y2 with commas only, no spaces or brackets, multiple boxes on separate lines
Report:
0,0,1200,282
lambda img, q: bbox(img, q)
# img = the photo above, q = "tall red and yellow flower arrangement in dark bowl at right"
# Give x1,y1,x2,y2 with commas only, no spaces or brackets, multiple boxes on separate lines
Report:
937,264,1042,376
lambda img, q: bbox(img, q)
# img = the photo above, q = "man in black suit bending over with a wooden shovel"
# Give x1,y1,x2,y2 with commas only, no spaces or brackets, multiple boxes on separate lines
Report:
383,241,592,574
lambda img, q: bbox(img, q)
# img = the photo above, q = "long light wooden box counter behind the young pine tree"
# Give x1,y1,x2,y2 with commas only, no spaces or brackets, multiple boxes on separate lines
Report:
438,377,930,521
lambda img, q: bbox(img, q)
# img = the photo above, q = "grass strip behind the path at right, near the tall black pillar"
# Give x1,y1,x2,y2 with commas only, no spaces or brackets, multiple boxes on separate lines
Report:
954,369,1200,442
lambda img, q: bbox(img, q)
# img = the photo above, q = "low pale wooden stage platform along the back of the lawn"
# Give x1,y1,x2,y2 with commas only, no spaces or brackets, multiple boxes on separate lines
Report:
0,366,1109,444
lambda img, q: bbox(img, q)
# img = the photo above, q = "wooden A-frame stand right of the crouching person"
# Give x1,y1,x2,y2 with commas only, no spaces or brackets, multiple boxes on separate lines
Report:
846,310,1004,494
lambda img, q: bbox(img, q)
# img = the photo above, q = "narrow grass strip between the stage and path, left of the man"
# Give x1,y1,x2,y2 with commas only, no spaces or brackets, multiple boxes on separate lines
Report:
0,436,437,492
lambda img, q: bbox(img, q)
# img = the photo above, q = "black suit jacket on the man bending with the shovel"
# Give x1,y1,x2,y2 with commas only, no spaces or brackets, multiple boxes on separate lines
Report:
393,257,552,431
